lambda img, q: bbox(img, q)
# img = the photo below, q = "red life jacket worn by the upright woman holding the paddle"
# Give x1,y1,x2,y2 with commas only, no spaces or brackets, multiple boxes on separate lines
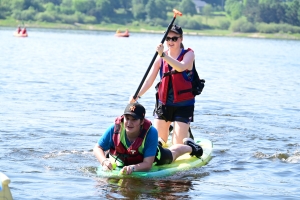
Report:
158,48,195,105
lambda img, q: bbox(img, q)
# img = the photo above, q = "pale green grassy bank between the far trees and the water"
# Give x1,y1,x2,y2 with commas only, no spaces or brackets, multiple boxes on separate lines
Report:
0,18,300,40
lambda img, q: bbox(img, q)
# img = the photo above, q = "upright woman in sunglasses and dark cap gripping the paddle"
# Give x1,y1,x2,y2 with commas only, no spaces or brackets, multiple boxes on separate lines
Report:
130,25,195,145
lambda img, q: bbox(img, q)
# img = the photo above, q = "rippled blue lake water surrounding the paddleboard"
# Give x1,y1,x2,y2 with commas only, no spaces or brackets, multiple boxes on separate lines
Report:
0,28,300,200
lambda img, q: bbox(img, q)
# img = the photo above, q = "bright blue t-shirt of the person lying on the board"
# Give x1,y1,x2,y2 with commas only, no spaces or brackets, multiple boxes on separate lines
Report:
98,124,158,158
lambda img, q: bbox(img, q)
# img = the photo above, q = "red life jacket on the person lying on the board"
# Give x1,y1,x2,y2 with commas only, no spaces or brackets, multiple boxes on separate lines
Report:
109,116,152,166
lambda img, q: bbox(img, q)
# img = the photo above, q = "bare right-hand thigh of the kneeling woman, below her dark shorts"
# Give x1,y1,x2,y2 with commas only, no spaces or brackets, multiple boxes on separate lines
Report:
171,122,190,144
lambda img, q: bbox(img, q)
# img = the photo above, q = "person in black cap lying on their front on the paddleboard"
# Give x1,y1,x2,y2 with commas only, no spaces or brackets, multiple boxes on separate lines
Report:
93,103,203,174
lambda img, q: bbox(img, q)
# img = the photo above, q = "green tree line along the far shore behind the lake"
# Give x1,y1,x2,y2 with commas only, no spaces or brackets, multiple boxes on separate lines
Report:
0,0,300,32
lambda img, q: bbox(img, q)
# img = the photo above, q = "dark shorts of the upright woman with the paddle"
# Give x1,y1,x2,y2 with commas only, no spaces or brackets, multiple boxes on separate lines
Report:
153,103,195,124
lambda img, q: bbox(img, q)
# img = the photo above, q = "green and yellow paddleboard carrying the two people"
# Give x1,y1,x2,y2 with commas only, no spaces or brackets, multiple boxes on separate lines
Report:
97,138,213,178
